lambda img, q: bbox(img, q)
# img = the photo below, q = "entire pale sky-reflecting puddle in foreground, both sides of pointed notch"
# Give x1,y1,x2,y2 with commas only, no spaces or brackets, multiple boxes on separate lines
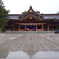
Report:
6,51,59,59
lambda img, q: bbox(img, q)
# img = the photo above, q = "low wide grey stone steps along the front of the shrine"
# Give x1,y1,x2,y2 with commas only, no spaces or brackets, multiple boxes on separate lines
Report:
5,31,54,34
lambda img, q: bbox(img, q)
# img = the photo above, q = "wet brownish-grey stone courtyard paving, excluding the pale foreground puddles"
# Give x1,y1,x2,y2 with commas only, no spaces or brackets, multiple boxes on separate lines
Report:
0,34,59,58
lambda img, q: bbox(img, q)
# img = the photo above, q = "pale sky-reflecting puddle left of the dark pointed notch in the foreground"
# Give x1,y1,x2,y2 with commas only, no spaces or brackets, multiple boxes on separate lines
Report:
6,51,30,59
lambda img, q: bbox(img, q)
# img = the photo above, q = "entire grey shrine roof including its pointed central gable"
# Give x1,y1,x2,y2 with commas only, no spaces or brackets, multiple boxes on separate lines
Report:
8,6,59,21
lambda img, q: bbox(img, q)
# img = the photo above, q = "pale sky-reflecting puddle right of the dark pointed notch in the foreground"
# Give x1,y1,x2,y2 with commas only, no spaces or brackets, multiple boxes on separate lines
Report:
32,51,59,59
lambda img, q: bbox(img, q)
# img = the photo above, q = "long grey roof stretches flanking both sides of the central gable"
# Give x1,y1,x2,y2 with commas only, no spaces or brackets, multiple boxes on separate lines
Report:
9,14,59,20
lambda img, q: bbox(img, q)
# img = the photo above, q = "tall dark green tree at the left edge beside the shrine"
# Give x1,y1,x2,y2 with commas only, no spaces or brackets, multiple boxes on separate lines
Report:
0,0,9,32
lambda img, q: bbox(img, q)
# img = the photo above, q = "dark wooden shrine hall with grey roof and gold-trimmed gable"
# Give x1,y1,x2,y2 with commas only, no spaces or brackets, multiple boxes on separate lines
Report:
5,6,59,31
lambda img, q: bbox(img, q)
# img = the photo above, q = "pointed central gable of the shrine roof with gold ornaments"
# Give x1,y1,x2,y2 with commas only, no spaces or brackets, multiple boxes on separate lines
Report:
19,6,43,19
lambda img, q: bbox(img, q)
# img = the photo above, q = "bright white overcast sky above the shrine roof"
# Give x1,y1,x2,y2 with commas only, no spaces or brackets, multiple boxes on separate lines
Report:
2,0,59,14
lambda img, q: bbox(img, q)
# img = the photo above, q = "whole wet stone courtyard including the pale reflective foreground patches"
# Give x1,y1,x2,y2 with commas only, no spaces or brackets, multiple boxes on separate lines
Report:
0,34,59,59
